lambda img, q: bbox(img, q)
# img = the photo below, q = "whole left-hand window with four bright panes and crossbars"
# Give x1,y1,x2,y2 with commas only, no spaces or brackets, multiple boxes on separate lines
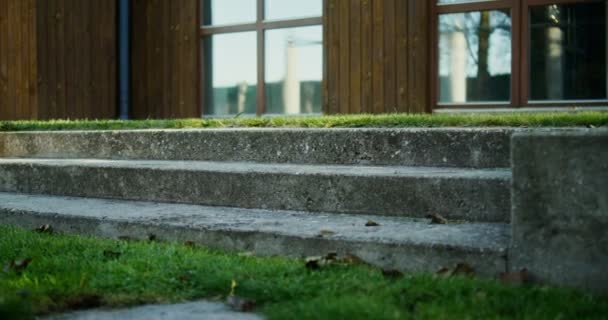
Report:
201,0,323,116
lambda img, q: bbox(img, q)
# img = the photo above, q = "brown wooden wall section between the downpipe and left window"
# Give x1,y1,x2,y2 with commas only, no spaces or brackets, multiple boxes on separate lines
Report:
131,0,201,118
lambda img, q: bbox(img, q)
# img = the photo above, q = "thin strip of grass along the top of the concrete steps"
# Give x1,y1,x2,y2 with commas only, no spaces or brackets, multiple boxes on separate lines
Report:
0,112,608,131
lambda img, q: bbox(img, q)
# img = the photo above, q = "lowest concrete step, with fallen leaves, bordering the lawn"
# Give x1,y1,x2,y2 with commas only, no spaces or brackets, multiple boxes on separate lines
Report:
0,193,510,275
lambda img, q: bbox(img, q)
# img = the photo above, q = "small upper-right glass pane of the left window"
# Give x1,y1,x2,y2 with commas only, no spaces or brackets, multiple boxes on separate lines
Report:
265,0,323,20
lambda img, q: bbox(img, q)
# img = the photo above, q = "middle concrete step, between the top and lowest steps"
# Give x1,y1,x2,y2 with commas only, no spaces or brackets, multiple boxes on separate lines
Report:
0,159,511,222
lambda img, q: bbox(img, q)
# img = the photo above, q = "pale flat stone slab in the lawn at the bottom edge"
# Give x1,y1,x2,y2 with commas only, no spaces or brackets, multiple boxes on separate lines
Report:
41,301,262,320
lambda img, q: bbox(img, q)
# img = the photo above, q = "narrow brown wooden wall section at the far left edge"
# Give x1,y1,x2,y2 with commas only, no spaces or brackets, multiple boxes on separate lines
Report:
0,0,38,120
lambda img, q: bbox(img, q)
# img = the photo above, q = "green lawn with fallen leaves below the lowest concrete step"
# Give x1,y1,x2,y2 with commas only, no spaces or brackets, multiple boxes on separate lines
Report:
0,226,608,320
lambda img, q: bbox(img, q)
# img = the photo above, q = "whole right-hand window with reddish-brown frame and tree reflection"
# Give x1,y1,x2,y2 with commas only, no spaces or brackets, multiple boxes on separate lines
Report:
432,0,608,107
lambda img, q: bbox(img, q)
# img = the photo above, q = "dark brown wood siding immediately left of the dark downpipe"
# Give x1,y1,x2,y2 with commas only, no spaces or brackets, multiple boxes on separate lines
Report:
36,0,117,119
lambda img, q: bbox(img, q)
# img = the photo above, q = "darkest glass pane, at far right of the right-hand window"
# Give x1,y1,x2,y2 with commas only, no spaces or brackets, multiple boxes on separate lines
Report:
529,1,608,100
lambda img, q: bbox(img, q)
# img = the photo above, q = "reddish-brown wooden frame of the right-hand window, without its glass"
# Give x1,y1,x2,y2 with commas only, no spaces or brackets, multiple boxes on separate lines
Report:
429,0,608,109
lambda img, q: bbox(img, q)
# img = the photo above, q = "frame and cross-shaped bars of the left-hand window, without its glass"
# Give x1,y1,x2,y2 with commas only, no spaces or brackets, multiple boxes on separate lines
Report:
198,0,326,117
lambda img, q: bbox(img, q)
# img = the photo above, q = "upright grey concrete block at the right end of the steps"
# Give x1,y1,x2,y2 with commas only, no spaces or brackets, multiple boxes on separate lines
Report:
509,129,608,292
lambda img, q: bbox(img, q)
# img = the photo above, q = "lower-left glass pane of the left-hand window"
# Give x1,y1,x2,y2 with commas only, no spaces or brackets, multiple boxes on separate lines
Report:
203,32,257,115
